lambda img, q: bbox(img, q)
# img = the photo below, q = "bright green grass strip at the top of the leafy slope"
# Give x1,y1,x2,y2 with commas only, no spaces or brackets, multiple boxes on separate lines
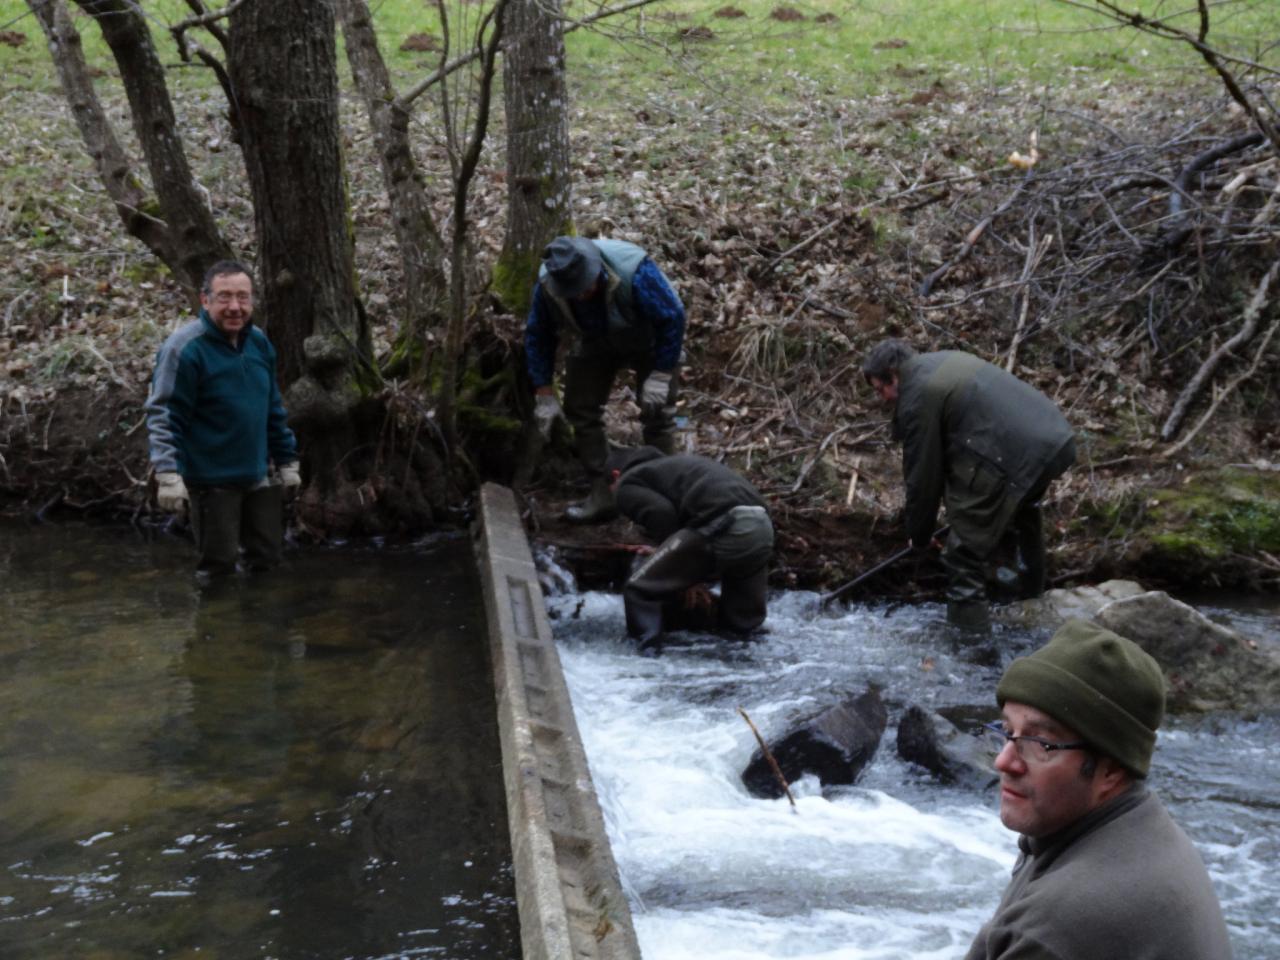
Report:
0,0,1280,104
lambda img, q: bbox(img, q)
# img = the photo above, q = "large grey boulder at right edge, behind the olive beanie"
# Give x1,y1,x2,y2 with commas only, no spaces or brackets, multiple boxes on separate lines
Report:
1093,590,1280,713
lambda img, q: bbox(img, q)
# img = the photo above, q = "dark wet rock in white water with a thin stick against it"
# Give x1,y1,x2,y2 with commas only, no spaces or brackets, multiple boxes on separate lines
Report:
742,690,888,799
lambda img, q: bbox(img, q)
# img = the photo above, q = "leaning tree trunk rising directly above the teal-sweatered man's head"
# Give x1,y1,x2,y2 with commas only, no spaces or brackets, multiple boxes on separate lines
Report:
77,0,230,291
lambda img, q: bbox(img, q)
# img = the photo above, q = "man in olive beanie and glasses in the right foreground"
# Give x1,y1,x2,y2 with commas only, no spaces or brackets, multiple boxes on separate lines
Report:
966,620,1231,960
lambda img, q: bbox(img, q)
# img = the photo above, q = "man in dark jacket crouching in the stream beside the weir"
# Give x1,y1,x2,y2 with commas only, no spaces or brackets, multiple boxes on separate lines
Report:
607,447,773,654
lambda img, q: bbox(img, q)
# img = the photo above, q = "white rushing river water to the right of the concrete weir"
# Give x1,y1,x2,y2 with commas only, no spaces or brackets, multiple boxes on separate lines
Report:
549,578,1280,960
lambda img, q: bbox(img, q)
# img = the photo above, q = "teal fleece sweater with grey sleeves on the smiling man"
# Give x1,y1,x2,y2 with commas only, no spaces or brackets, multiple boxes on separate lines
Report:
146,310,298,486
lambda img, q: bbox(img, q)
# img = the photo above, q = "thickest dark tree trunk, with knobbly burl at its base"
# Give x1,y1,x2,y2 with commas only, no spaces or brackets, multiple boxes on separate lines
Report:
228,0,378,531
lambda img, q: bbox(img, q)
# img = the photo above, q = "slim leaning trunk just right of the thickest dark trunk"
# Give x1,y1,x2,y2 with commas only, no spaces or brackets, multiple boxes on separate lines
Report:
338,0,448,366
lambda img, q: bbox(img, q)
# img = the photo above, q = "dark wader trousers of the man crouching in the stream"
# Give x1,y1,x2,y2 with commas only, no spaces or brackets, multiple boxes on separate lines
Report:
622,507,773,650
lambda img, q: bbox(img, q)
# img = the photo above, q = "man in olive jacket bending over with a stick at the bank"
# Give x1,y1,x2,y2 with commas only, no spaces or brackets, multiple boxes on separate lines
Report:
863,339,1075,631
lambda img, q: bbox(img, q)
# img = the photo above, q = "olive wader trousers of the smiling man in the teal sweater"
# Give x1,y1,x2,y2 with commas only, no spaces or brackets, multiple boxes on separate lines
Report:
191,483,284,576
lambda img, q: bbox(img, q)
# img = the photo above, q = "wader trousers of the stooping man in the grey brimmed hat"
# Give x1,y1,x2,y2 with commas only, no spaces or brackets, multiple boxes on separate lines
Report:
564,349,680,480
